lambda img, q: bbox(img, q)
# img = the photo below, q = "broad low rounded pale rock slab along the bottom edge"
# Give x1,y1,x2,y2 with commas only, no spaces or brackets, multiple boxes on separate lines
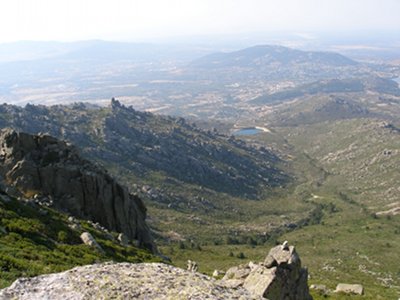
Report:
0,263,261,300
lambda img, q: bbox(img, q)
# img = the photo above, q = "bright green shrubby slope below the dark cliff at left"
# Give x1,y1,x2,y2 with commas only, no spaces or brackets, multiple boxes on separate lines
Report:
0,194,160,288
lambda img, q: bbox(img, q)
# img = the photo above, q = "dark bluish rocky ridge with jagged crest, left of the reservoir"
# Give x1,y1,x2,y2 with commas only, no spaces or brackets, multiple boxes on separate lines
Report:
0,100,288,202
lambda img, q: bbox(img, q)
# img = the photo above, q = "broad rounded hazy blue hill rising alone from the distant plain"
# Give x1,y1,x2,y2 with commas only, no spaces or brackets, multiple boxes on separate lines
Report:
183,45,368,84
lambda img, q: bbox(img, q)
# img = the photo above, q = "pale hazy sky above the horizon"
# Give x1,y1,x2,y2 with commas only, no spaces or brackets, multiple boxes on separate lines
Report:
0,0,400,42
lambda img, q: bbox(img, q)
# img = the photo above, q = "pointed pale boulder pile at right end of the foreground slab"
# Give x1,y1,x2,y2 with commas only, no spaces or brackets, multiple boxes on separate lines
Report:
221,242,312,300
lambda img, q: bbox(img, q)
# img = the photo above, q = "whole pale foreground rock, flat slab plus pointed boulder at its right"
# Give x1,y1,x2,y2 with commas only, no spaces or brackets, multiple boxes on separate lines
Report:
0,243,312,300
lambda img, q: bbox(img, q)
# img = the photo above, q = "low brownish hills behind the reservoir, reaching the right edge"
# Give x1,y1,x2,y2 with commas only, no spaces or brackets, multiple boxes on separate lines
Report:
247,77,400,127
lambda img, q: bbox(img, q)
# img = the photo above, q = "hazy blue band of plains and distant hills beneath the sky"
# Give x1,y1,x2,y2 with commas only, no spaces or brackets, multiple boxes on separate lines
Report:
0,41,400,122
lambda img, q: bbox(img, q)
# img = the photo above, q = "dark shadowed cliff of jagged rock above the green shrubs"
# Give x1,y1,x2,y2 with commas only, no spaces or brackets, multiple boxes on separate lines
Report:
0,129,156,252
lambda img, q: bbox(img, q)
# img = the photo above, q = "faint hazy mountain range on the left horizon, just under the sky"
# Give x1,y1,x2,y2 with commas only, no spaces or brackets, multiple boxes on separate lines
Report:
0,40,209,64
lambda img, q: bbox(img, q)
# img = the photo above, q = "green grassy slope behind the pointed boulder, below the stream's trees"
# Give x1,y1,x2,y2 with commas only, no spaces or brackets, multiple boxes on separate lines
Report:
161,195,400,300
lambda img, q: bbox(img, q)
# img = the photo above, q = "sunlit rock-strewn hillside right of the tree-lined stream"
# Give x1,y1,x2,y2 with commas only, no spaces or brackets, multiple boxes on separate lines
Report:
276,118,400,209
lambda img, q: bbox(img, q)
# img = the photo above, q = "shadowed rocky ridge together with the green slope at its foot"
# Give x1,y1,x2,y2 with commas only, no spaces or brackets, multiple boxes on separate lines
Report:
0,100,314,251
